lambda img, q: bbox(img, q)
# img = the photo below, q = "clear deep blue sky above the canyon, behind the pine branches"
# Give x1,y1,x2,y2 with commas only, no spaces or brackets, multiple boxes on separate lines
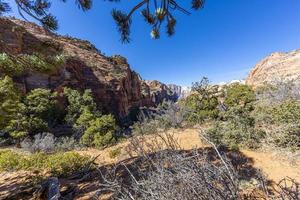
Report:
5,0,300,86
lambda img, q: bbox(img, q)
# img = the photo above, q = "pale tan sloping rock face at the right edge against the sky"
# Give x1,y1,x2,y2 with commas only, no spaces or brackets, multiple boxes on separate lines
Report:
246,50,300,88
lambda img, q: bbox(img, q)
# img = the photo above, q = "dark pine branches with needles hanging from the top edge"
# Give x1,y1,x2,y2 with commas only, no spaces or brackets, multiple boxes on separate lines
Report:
0,0,205,43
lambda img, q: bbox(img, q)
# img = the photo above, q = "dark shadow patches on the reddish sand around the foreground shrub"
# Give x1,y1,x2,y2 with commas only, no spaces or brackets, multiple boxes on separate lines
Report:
0,147,271,199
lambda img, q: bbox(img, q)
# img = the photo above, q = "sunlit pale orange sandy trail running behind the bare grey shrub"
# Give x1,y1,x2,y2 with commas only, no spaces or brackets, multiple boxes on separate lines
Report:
80,129,300,182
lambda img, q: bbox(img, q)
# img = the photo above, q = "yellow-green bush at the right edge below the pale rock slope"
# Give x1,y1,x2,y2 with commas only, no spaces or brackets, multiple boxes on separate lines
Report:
252,99,300,149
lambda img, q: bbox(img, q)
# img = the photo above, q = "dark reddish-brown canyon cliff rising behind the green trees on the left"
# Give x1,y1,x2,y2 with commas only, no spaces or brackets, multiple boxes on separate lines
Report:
0,17,175,119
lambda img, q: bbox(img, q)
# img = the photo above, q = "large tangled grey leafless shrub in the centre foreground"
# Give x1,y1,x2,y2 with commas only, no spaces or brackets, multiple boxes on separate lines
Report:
98,134,239,200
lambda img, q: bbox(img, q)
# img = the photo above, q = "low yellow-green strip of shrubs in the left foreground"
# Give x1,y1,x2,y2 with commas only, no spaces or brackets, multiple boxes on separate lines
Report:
0,150,91,177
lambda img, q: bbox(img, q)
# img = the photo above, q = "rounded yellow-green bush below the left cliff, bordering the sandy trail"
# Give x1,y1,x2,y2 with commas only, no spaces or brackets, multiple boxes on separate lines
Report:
81,115,117,147
